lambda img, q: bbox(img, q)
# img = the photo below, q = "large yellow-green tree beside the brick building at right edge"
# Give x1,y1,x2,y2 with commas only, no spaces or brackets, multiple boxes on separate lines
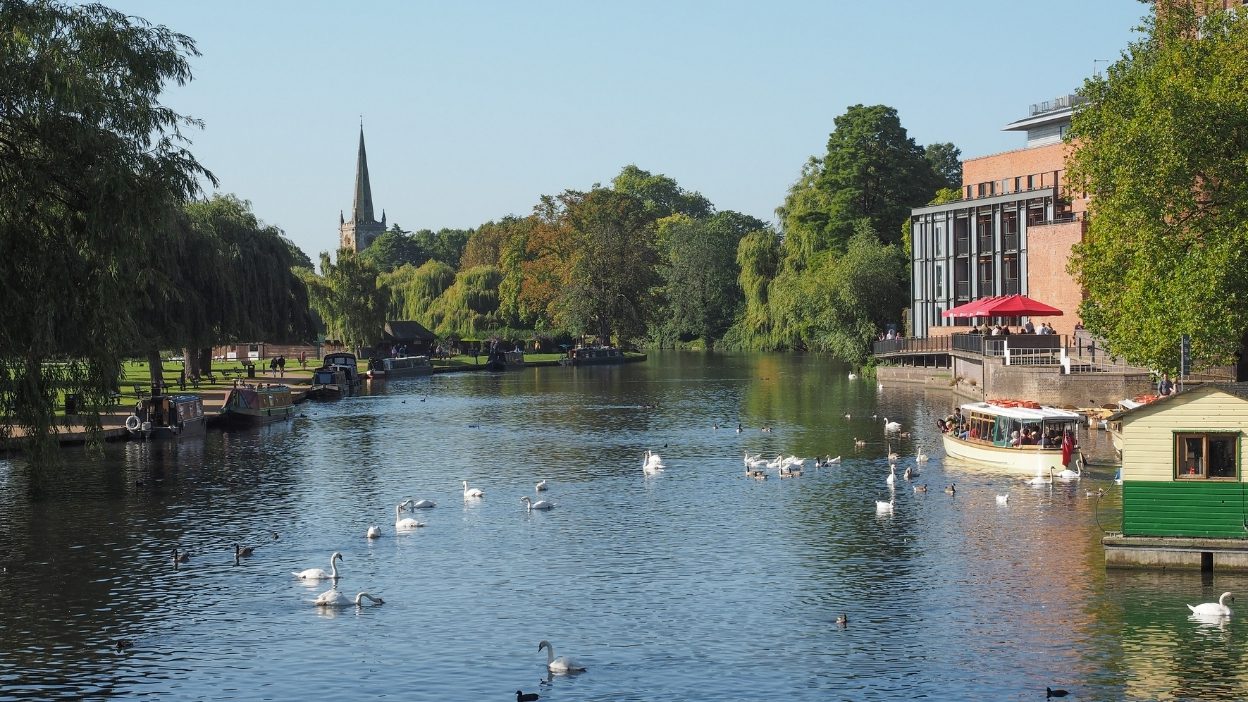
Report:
1067,4,1248,380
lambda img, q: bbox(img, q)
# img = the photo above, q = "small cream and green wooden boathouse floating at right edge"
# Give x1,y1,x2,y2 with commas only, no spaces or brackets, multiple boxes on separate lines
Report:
1102,382,1248,571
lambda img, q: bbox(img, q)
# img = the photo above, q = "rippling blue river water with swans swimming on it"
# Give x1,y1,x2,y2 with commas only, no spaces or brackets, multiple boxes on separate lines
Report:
0,352,1248,702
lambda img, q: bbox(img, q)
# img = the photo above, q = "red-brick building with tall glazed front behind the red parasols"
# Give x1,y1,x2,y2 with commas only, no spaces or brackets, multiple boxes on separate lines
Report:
910,95,1087,337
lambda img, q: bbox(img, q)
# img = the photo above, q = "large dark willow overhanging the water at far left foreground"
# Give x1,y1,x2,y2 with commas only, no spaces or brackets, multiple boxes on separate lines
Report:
0,0,211,460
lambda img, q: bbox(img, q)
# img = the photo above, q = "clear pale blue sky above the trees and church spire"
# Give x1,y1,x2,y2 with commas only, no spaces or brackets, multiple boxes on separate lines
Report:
105,0,1148,259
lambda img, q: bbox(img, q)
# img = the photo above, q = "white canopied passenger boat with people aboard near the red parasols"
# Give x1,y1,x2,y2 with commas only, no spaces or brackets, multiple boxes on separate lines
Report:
941,400,1083,475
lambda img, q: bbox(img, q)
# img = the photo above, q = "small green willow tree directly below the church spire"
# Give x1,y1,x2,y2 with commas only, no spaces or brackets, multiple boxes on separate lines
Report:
305,249,388,351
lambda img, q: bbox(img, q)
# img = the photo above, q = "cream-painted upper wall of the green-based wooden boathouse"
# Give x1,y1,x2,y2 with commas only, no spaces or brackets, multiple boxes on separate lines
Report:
1122,388,1248,481
